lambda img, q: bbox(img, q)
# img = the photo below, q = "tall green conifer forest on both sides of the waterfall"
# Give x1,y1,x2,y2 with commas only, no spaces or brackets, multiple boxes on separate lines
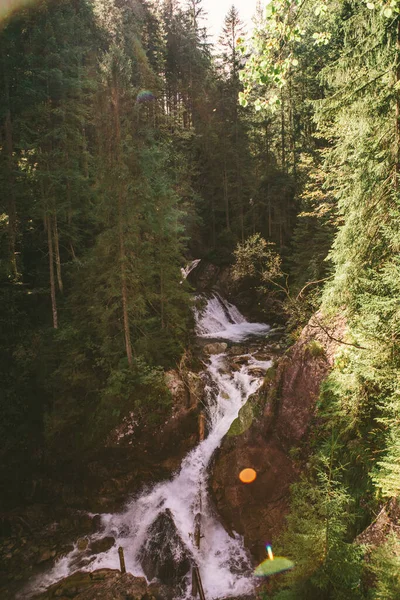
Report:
0,0,400,600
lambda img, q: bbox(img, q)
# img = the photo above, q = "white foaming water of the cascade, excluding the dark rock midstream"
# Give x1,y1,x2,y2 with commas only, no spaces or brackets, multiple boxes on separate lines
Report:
24,294,270,600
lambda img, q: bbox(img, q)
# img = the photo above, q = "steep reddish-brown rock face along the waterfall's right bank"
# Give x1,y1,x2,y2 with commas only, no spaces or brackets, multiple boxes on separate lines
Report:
211,313,346,559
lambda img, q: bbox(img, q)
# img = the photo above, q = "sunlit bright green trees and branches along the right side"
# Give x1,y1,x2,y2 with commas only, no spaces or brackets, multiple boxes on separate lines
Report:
241,0,400,600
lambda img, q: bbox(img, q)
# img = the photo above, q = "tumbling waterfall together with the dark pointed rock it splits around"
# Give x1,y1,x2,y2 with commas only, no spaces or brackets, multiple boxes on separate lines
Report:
21,293,272,599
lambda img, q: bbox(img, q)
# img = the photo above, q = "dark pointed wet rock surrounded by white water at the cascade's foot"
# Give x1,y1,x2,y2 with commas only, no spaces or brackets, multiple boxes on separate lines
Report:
139,509,191,585
